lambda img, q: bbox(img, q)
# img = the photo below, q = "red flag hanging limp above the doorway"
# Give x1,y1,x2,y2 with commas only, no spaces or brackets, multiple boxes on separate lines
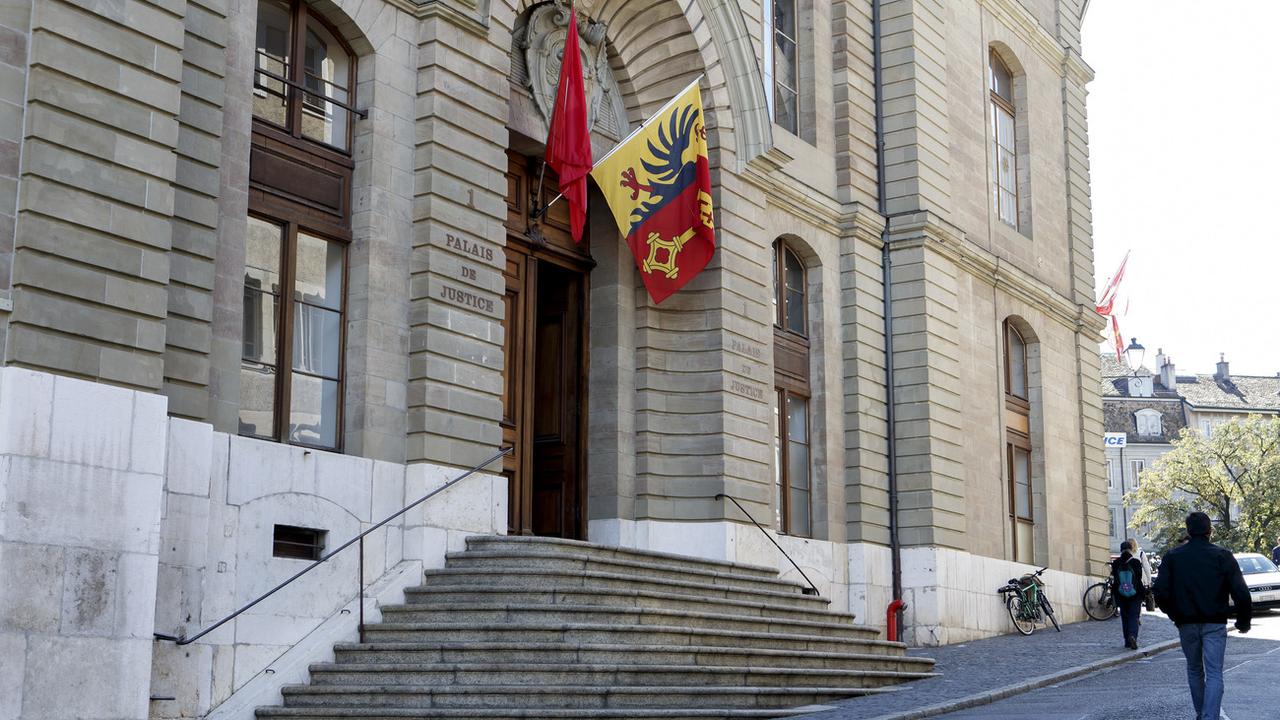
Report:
547,4,593,242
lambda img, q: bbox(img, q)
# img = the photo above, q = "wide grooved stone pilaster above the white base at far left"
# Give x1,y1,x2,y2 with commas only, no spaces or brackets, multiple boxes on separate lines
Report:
5,0,186,391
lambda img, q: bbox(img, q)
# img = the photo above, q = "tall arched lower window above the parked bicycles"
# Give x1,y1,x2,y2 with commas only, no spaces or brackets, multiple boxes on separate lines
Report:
1004,320,1036,564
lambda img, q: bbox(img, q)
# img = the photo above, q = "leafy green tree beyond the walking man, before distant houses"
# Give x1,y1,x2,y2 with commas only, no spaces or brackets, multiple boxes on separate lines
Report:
1125,415,1280,553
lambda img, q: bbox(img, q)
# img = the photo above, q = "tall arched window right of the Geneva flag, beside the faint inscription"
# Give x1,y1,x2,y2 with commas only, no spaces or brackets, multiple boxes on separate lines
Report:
773,240,813,537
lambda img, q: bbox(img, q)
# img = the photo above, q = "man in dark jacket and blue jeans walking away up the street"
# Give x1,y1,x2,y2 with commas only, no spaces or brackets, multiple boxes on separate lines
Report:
1155,512,1253,720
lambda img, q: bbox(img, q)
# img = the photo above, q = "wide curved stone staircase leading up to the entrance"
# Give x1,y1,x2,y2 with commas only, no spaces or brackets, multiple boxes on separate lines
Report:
257,536,933,720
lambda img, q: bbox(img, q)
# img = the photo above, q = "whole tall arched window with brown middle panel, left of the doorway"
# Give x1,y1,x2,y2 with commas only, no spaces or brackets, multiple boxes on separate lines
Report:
239,0,357,450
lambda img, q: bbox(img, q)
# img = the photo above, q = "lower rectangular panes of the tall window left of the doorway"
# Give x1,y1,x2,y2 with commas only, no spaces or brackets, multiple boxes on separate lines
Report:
239,217,347,450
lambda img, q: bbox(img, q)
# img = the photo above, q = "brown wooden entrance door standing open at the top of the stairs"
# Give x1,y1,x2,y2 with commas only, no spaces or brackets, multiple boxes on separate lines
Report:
502,154,594,539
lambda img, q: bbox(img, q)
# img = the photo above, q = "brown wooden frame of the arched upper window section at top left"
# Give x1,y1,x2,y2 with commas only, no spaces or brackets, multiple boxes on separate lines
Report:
250,0,358,158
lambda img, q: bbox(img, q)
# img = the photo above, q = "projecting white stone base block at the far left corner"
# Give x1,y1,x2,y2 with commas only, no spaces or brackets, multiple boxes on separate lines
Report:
0,366,168,720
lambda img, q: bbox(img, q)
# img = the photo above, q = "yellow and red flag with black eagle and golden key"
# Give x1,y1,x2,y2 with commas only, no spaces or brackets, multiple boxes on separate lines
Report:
591,81,716,302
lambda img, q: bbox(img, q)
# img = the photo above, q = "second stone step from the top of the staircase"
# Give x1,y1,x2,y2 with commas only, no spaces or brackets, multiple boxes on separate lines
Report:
445,546,819,601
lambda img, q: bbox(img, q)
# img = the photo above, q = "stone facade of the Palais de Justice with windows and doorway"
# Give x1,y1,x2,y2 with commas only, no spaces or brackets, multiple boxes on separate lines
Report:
0,0,1107,717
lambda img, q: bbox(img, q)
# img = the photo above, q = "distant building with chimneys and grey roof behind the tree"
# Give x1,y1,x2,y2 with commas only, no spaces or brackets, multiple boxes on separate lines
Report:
1101,350,1280,552
